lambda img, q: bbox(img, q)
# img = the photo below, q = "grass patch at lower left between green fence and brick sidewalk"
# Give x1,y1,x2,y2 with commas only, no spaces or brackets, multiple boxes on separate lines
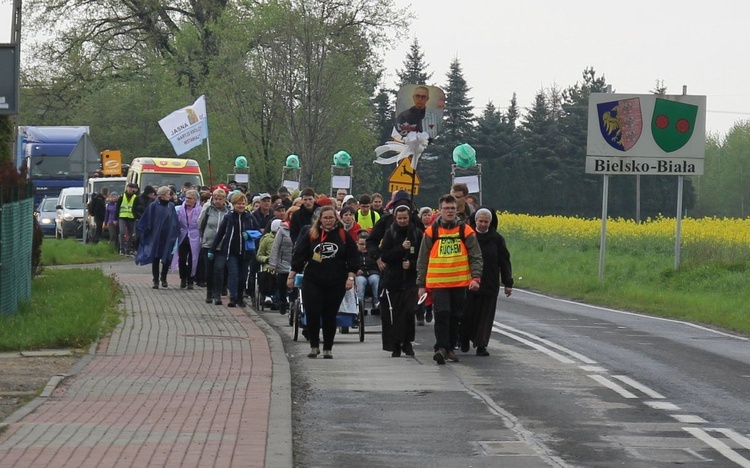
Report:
0,266,122,351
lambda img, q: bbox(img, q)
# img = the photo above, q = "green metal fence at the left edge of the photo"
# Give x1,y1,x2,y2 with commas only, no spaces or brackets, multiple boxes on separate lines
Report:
0,185,34,315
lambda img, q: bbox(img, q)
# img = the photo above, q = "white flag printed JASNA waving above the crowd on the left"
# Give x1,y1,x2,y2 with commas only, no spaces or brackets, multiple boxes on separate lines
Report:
159,96,208,156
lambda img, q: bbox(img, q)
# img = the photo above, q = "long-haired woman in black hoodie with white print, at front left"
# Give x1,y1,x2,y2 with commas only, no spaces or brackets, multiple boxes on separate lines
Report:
286,204,359,359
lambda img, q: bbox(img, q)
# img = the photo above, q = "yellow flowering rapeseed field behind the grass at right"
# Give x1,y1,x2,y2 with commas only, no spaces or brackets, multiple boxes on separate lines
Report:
498,212,750,263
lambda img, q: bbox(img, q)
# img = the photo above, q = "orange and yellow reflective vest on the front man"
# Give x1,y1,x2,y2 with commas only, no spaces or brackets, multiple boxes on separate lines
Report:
425,226,474,288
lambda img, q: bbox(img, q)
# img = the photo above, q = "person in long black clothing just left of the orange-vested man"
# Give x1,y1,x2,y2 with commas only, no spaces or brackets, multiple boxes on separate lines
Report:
380,205,422,357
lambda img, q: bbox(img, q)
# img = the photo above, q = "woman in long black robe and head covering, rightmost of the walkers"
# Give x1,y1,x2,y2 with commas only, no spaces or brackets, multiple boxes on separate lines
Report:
459,207,513,356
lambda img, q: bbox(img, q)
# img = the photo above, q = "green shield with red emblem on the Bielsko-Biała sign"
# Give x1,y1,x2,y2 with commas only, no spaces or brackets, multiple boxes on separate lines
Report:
651,98,698,153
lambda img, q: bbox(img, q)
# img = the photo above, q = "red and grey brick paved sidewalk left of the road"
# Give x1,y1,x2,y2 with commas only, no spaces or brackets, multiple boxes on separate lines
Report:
0,260,292,467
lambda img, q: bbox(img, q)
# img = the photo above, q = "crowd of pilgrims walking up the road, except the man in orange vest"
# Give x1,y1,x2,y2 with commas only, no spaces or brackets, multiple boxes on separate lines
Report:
114,183,513,361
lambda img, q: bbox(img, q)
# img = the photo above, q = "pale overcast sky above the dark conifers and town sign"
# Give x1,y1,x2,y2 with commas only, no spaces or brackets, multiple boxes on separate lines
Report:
0,0,750,134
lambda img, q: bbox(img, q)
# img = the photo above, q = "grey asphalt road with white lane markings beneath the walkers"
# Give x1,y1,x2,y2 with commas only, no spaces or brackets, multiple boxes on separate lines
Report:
261,290,750,468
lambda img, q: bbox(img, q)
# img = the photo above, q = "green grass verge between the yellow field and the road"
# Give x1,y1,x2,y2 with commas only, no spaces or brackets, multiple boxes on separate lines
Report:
506,237,750,334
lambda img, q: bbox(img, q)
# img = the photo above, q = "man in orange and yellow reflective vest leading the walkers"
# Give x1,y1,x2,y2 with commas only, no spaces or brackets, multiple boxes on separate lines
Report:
417,194,482,365
